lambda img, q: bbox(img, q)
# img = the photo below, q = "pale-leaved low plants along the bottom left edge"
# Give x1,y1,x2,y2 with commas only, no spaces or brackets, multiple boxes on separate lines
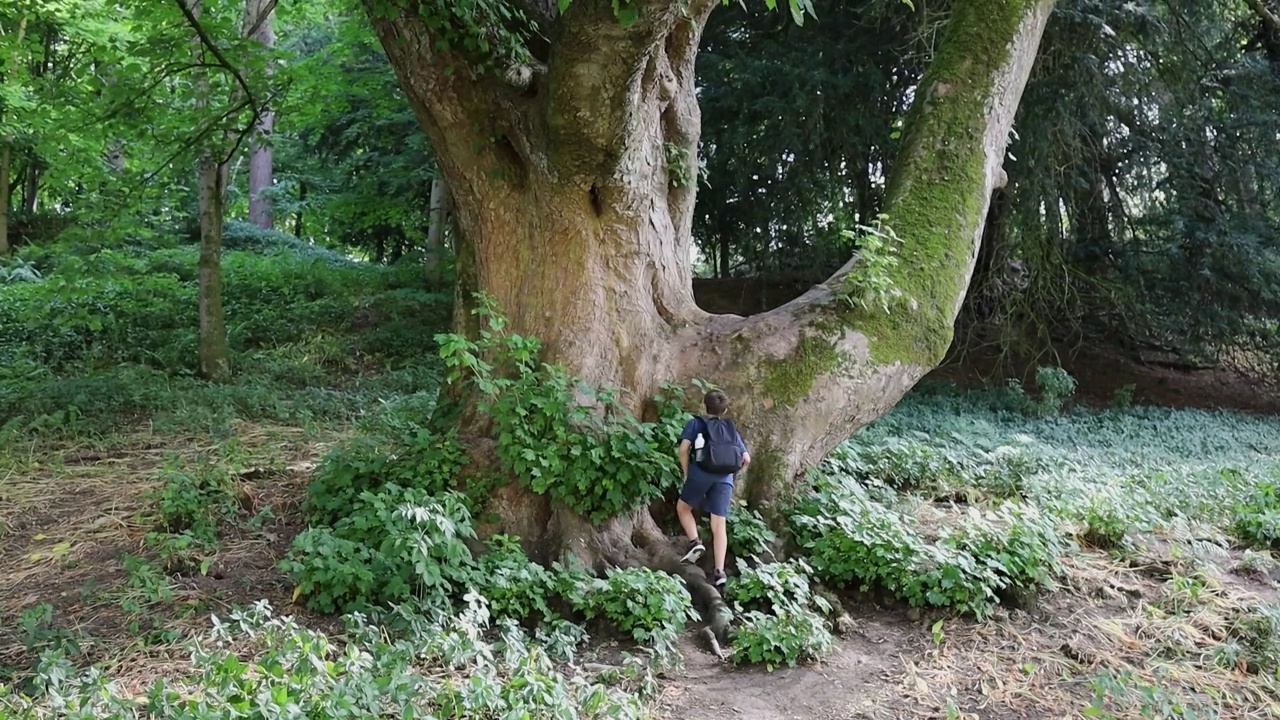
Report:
0,601,653,720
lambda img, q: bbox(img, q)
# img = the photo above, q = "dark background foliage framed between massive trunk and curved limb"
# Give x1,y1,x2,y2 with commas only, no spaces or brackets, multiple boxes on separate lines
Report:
694,0,946,279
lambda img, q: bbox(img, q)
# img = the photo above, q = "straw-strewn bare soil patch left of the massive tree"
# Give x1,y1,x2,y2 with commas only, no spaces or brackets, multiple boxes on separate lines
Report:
0,425,332,671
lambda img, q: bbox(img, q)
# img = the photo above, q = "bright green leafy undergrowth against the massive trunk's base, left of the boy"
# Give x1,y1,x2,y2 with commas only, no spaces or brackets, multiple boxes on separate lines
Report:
282,294,706,657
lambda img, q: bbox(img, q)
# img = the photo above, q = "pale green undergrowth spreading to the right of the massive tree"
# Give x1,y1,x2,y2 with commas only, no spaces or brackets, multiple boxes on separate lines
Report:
790,369,1280,618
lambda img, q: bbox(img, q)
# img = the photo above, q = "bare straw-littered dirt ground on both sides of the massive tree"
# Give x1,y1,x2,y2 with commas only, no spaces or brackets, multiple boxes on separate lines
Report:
0,354,1280,720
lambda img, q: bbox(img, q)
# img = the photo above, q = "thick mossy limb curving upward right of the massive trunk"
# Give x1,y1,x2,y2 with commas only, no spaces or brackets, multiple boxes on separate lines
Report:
681,0,1053,505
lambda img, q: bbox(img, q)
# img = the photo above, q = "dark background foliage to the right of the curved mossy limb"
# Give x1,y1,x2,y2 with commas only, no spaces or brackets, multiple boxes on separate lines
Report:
963,0,1280,368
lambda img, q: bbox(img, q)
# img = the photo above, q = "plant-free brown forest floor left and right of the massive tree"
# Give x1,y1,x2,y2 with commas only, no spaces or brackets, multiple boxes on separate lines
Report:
0,351,1280,720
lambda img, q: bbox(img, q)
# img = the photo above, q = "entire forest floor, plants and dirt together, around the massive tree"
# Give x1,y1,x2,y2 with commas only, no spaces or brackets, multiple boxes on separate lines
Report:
0,247,1280,719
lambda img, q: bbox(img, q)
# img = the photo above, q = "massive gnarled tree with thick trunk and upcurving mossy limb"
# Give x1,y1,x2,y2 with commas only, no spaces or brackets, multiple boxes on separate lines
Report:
366,0,1053,564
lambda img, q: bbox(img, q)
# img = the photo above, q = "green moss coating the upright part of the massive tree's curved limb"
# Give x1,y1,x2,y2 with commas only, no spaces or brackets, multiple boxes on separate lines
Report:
842,0,1036,366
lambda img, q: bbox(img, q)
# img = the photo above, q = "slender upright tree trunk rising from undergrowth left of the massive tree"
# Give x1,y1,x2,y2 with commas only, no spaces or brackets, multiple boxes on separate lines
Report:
187,0,230,382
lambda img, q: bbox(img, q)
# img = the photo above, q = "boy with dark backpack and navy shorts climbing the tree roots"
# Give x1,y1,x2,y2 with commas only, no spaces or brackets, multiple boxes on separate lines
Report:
676,389,751,588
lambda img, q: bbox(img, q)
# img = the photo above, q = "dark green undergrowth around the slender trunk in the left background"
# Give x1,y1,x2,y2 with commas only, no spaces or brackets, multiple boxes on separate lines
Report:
0,233,451,442
